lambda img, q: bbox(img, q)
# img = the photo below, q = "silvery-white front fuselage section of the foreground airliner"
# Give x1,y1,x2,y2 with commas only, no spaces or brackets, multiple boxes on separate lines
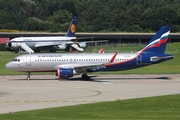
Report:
6,53,138,72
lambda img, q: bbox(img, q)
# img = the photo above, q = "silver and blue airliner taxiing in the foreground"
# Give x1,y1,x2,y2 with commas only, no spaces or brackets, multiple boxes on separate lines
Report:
6,26,174,80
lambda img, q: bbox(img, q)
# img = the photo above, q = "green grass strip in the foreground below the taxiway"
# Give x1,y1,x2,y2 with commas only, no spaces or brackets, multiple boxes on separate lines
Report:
0,94,180,120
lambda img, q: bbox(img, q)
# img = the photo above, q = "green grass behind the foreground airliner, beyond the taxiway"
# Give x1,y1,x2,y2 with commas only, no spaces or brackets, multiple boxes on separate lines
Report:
0,42,180,75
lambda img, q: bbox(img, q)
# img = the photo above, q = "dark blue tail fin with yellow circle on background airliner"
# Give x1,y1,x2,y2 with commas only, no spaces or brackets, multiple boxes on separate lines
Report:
65,17,76,37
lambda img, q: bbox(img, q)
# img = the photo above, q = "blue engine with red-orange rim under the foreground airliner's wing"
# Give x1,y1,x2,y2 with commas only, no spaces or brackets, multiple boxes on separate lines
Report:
56,68,76,79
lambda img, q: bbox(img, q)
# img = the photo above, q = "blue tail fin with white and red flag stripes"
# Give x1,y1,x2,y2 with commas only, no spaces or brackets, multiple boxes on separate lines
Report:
139,26,170,54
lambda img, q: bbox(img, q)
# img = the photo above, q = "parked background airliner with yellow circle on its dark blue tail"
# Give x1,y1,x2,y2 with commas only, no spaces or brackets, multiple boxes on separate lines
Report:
5,17,107,53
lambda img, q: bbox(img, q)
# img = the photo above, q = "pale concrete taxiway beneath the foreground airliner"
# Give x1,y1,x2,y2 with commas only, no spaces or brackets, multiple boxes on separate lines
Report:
0,74,180,113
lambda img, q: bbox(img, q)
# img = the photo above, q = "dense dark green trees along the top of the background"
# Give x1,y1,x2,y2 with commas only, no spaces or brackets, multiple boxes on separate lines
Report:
0,0,180,32
